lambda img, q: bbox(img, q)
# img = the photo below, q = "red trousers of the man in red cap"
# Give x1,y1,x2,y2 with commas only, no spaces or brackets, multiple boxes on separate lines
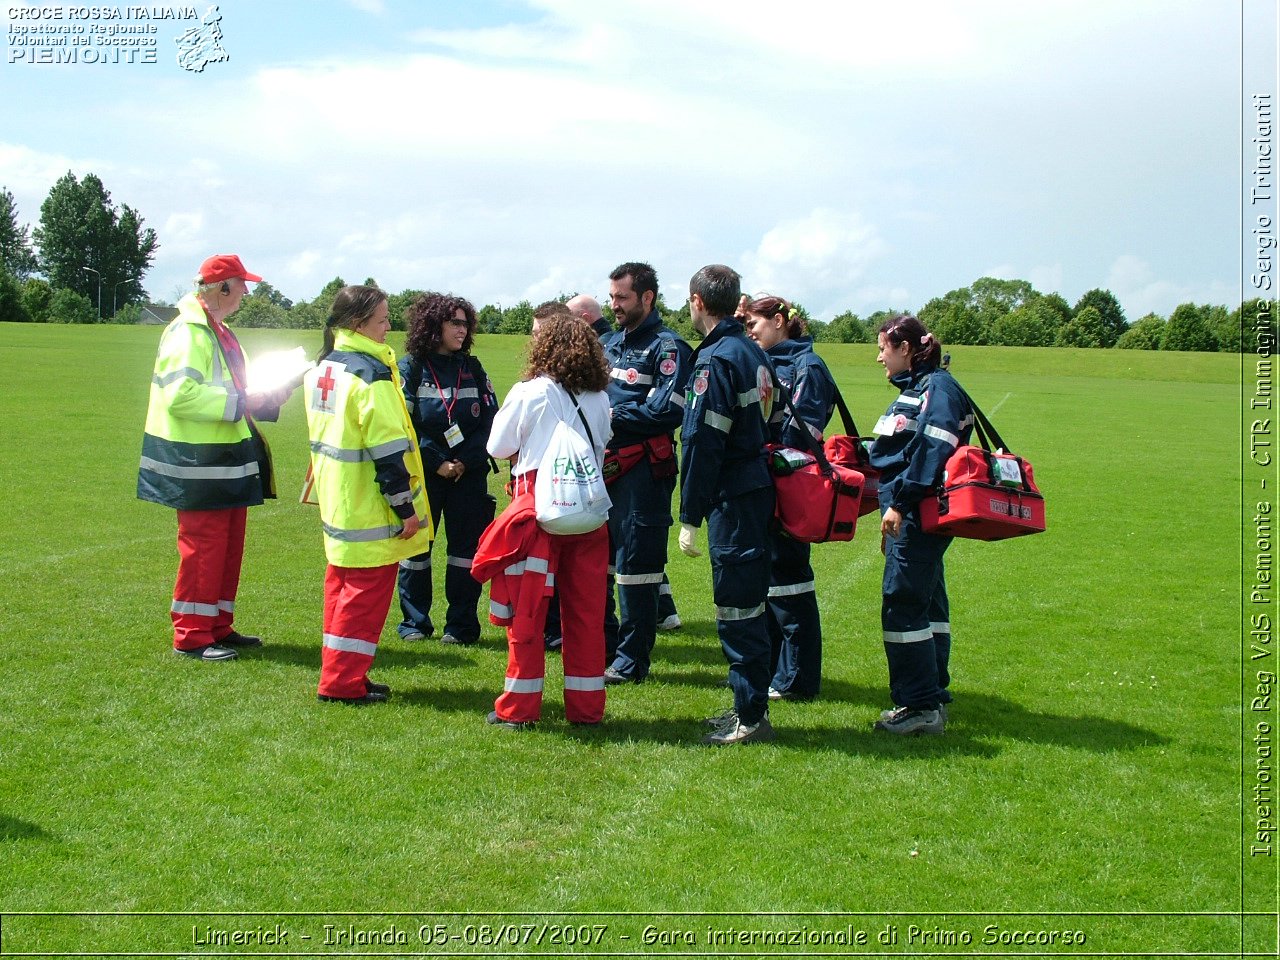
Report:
169,507,248,650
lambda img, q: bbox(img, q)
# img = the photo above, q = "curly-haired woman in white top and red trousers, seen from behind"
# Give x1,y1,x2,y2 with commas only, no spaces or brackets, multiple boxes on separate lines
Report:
471,316,611,730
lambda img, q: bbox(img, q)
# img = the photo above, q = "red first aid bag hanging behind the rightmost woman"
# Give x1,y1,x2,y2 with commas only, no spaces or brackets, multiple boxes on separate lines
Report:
920,394,1044,540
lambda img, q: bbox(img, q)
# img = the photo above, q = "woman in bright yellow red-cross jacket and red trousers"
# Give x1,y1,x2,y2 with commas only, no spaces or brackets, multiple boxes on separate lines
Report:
303,287,433,705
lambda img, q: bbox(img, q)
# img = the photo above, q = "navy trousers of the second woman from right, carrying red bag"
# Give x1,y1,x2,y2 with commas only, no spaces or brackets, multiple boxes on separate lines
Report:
768,534,822,696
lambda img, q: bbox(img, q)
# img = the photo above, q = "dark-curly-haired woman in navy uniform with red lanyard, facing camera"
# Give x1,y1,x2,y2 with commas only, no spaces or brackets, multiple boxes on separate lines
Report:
399,293,498,644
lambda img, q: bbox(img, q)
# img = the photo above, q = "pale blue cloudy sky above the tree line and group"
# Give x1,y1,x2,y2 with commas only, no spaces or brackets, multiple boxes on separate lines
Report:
0,0,1275,320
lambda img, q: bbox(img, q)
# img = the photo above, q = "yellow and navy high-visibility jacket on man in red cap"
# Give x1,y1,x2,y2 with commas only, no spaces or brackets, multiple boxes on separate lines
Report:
138,293,269,509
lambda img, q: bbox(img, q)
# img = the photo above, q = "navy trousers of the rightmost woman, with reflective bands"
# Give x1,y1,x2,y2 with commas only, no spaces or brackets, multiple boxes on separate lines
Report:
881,511,951,709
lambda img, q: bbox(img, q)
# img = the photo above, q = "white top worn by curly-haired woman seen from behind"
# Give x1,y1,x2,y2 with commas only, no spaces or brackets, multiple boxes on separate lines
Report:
488,376,613,476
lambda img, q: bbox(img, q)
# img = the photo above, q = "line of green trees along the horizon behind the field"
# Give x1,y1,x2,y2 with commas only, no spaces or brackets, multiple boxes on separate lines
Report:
0,172,1276,352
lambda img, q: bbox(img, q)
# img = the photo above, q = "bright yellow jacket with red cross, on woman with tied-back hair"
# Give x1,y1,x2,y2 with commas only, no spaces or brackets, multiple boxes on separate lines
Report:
302,329,434,567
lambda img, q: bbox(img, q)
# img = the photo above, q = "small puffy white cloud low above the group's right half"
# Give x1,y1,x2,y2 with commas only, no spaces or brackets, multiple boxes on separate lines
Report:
742,207,886,319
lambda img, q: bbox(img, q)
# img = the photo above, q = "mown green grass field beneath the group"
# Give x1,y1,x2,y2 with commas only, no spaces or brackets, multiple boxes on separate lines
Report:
0,325,1259,956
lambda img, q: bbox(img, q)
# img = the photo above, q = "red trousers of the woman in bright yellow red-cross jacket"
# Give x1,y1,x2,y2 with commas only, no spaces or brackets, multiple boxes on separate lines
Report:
316,563,397,699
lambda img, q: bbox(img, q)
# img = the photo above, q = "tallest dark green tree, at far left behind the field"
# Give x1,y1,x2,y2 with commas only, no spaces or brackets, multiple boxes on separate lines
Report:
35,172,159,319
